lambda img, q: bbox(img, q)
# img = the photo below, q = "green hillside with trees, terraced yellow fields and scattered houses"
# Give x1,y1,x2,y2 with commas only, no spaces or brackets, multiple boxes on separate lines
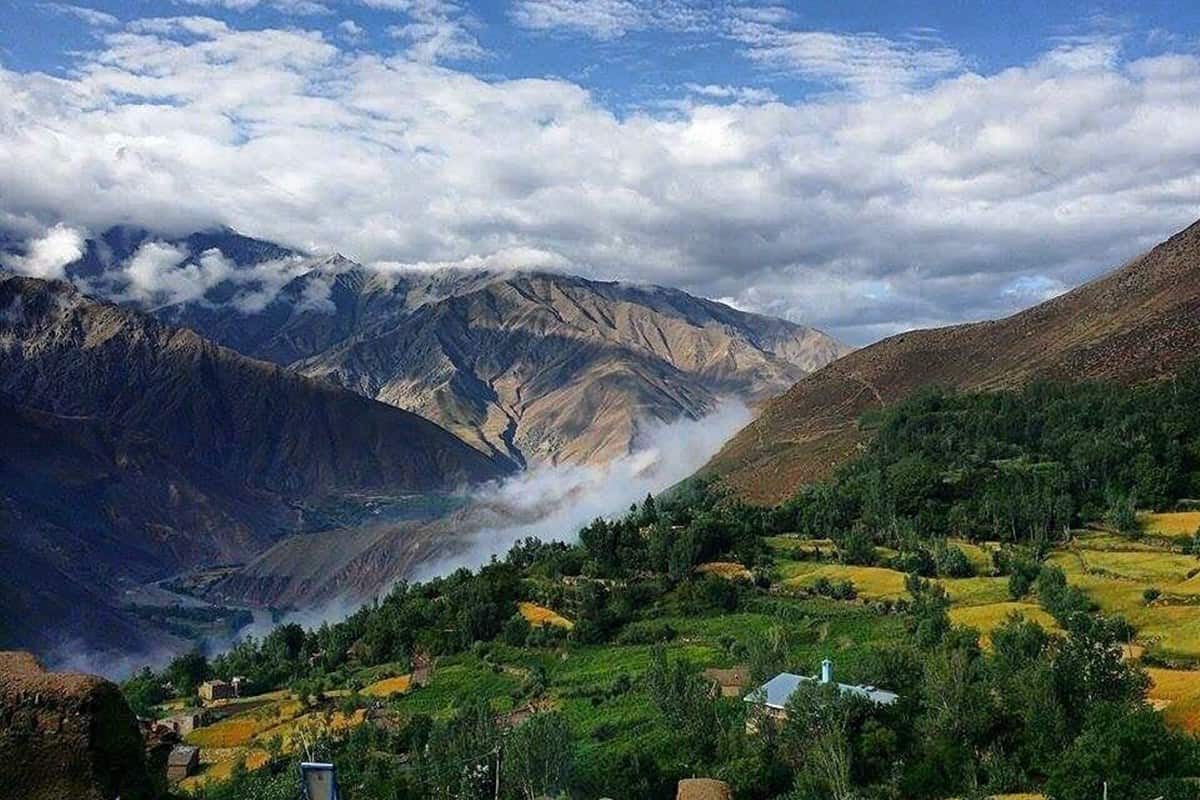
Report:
133,377,1200,800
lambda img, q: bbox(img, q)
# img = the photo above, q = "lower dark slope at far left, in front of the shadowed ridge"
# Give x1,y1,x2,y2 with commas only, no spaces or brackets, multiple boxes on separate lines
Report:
0,401,280,655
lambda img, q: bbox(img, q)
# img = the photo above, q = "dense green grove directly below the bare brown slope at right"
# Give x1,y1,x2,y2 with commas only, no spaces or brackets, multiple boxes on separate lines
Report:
770,372,1200,554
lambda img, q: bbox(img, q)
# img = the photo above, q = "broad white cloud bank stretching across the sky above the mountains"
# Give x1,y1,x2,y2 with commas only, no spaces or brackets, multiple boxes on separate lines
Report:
0,21,1200,343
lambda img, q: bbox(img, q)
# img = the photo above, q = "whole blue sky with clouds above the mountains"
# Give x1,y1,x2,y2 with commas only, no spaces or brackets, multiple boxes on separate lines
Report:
0,0,1200,344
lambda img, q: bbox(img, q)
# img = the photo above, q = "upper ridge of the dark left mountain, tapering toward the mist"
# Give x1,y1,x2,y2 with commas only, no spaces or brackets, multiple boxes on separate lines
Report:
0,275,503,494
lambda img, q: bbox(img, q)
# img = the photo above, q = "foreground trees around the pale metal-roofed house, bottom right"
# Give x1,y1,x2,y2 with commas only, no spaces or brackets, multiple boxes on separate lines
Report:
646,592,1200,800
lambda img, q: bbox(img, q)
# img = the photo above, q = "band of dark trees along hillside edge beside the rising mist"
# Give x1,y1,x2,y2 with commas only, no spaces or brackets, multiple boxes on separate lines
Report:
125,486,767,714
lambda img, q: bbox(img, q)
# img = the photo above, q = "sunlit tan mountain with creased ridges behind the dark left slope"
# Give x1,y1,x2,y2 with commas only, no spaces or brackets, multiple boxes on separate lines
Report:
166,267,848,463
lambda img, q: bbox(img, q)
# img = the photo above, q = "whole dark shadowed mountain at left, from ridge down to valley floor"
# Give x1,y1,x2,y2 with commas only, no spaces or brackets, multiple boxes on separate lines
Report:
0,273,508,654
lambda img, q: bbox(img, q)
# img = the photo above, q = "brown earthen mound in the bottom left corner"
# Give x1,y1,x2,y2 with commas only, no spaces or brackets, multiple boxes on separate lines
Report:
0,652,158,800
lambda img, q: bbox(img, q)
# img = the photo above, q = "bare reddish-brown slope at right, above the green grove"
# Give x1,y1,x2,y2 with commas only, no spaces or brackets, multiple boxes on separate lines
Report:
701,217,1200,503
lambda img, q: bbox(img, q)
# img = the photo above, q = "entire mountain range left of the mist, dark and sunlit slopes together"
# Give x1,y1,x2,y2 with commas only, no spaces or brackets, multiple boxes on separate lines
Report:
0,228,847,652
